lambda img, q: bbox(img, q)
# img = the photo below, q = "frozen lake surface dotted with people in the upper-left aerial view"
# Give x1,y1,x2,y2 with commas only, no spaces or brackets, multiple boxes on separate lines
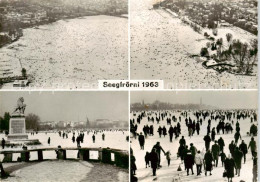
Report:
0,15,128,89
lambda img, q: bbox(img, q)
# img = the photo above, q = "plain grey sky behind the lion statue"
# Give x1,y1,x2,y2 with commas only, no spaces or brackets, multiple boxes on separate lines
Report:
0,91,128,122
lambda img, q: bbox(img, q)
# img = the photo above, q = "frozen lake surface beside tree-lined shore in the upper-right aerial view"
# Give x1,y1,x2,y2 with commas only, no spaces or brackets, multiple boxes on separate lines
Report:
130,0,257,89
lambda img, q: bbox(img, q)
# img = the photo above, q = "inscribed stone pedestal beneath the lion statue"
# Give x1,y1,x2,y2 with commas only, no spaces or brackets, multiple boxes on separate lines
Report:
7,115,28,140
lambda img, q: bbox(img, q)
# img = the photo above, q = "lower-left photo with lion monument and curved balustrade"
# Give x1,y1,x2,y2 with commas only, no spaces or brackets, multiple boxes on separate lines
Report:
0,91,129,182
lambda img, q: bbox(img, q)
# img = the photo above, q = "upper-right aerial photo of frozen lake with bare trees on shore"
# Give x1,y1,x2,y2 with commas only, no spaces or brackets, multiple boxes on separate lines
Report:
129,0,258,89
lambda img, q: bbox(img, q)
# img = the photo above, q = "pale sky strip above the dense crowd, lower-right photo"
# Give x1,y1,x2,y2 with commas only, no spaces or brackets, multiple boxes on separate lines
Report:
130,91,258,109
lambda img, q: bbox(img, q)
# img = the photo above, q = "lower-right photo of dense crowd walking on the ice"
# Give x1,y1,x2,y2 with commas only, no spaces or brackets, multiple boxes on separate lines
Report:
130,91,258,182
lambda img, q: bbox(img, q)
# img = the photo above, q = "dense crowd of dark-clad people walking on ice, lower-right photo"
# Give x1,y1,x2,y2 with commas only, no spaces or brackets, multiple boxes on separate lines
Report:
130,110,257,181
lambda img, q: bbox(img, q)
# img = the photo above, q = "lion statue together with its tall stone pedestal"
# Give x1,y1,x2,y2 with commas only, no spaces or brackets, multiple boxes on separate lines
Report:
7,97,28,140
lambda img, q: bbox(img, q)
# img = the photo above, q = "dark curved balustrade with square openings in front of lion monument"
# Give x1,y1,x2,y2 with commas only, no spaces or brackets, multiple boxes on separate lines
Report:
0,148,129,169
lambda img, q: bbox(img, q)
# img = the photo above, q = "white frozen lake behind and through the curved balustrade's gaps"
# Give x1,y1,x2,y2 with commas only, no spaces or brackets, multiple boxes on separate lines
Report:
0,131,129,161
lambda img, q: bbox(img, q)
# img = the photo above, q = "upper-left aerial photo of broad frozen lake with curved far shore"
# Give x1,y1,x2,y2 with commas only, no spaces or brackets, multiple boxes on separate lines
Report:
0,0,128,89
